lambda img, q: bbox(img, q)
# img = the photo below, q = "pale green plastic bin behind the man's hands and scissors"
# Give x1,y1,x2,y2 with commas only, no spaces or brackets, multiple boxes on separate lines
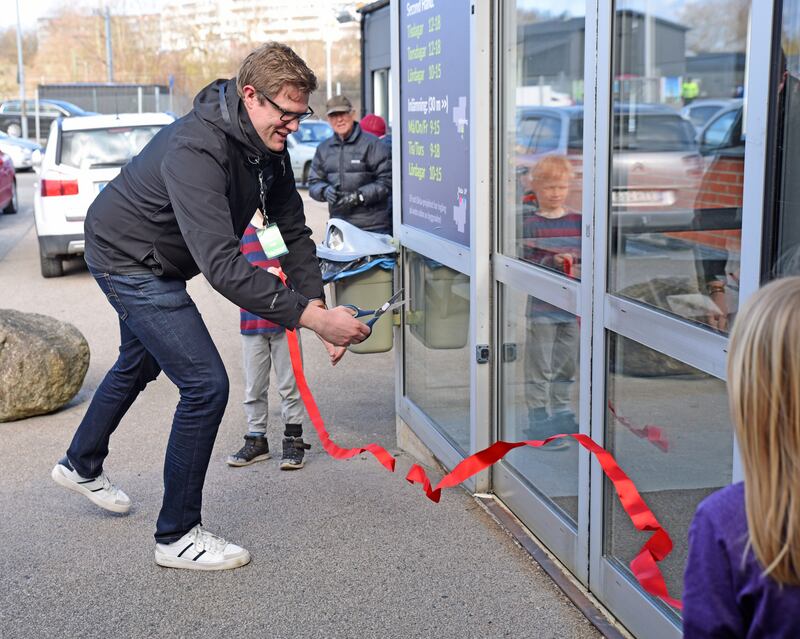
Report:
333,266,394,353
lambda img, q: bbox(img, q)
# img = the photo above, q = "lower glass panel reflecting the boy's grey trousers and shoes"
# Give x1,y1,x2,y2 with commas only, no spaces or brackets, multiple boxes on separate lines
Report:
500,287,580,525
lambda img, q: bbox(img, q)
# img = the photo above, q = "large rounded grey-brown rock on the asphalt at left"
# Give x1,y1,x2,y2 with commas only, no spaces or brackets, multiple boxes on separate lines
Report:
0,309,89,422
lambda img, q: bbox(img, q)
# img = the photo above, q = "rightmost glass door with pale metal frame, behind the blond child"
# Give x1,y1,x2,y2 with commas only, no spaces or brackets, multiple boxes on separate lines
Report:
590,0,770,637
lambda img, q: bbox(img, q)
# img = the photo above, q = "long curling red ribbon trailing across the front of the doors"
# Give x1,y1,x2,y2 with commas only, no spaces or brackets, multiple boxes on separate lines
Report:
278,270,682,609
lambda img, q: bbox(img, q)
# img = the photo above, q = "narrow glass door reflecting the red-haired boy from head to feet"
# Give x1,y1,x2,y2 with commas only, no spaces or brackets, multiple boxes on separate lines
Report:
493,0,593,582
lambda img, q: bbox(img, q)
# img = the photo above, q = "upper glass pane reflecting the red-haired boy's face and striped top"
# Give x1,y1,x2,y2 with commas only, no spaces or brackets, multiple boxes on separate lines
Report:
502,0,586,278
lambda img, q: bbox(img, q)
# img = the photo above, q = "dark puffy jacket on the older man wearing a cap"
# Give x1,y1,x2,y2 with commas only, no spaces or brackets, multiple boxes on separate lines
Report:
308,123,392,233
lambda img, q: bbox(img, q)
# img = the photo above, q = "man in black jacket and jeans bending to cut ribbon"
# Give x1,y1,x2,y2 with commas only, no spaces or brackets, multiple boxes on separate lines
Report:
51,43,369,570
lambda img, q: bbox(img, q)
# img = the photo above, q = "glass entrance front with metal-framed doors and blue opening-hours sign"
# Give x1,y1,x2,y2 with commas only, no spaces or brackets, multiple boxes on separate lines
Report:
384,0,800,639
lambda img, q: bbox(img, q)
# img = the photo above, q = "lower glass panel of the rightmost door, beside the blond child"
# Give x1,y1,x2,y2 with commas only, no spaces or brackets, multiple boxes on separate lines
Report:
604,334,733,612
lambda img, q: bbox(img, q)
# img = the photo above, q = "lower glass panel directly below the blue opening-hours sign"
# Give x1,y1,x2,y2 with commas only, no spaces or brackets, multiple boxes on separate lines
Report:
405,251,471,455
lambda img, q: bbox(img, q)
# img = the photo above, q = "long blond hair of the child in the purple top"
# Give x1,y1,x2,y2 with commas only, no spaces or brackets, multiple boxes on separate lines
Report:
728,277,800,585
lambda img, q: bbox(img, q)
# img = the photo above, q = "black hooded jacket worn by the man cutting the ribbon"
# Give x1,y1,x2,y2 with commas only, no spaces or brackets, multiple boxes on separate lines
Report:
84,79,323,328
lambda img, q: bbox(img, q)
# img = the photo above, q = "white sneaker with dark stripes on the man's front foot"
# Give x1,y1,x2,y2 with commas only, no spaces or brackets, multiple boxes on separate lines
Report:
156,524,250,570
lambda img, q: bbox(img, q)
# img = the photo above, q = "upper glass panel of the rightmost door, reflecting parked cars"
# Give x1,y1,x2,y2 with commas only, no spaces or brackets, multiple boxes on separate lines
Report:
608,0,750,333
